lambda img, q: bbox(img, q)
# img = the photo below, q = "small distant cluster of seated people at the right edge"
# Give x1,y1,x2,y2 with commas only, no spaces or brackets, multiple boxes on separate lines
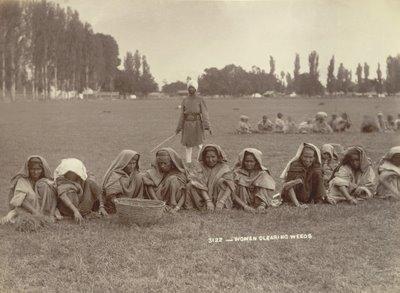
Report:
361,112,400,133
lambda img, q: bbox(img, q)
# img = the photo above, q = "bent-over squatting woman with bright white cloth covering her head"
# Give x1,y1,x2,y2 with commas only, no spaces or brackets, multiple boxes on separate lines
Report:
54,158,107,223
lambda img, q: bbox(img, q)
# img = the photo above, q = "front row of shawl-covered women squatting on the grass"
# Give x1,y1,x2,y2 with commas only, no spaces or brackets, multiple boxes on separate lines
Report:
2,143,400,223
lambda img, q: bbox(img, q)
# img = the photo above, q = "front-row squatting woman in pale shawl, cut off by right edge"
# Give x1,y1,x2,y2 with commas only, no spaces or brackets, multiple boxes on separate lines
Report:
376,146,400,199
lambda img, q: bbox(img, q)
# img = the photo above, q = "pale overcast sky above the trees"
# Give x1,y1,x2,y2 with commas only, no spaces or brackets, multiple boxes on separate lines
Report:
56,0,400,84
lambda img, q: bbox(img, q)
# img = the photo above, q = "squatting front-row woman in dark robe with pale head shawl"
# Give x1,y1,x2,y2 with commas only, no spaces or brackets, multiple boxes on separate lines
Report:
280,143,326,208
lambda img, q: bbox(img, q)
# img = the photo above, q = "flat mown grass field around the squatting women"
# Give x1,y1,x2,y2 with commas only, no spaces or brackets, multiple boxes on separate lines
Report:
0,98,400,292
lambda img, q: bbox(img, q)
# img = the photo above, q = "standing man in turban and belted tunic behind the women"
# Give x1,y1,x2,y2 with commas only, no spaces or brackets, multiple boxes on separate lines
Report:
176,79,211,165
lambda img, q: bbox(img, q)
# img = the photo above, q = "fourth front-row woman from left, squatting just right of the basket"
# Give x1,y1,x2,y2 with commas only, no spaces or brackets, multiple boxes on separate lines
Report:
143,148,188,213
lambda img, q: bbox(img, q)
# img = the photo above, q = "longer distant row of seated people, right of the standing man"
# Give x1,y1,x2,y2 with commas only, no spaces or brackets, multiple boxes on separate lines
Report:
236,112,351,134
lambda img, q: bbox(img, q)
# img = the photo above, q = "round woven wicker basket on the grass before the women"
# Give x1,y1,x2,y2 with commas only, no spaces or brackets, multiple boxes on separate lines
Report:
114,198,165,226
